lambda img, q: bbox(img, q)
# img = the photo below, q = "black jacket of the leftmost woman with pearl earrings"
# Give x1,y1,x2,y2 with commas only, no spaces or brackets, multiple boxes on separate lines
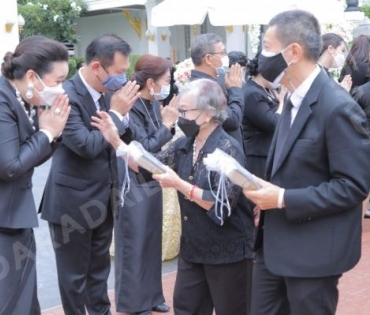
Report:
0,76,56,229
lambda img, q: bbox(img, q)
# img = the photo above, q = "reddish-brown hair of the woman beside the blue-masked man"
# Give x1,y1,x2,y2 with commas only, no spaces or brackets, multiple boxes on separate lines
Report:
131,54,172,90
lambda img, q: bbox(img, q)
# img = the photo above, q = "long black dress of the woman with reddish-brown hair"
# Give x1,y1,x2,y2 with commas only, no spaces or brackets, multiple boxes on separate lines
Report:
114,98,172,313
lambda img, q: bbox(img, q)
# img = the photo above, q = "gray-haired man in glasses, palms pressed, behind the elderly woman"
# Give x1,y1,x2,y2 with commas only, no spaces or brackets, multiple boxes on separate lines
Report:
190,33,244,145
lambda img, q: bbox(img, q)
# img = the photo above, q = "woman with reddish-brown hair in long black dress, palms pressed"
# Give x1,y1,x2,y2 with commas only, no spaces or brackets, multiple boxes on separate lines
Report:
114,55,178,315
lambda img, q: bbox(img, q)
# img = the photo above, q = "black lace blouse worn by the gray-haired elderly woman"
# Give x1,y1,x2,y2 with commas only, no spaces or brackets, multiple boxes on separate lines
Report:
156,127,254,264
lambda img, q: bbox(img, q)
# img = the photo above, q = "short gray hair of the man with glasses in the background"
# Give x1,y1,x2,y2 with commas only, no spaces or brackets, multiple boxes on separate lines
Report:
190,33,222,66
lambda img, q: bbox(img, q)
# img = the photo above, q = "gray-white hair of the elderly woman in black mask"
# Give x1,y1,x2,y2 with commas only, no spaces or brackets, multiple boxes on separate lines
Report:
179,79,227,125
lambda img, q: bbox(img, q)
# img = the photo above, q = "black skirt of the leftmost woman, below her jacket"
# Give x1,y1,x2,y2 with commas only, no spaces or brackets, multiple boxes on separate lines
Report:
0,228,41,315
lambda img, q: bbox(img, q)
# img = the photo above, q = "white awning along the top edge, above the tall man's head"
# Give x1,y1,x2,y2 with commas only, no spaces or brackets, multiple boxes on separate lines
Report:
151,0,344,27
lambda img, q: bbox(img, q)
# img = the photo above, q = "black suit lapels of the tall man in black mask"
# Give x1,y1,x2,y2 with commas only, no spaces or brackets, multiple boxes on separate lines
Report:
268,71,330,177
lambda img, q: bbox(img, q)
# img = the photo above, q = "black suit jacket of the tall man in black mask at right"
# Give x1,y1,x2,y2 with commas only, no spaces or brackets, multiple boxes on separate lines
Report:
260,71,370,277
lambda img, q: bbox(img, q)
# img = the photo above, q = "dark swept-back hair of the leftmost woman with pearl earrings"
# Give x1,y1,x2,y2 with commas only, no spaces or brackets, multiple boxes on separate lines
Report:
1,35,69,80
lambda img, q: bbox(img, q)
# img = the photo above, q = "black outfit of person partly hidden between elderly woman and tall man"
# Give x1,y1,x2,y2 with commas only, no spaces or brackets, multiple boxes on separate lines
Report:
243,79,280,178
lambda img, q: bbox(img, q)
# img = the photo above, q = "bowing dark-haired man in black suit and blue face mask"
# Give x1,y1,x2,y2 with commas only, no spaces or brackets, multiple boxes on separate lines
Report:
40,34,139,315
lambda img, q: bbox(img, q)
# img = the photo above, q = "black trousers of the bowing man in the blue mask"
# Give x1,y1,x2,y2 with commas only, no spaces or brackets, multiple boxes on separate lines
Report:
49,210,113,315
